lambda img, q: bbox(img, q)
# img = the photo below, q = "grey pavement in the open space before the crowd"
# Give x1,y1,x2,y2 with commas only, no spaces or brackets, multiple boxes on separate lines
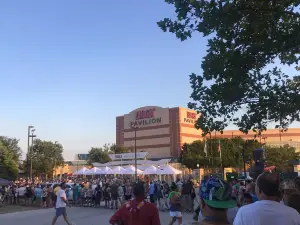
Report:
0,207,196,225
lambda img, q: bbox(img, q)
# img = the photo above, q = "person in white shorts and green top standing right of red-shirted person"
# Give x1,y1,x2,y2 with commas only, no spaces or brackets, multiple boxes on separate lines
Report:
168,183,182,225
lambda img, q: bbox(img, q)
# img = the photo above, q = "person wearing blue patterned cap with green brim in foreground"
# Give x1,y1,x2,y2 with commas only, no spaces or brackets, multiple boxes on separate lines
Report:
199,177,236,225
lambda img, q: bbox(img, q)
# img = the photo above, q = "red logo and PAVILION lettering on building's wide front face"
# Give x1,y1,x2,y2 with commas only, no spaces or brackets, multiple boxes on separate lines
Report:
130,108,161,127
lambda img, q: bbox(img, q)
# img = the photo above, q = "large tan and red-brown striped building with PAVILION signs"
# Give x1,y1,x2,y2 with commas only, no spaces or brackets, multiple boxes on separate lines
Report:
116,106,300,159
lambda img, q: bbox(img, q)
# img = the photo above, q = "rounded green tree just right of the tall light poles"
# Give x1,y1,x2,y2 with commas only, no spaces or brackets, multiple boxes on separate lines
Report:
28,139,64,176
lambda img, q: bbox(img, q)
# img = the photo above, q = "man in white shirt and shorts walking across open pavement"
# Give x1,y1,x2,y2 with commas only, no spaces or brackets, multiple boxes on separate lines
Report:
52,182,72,225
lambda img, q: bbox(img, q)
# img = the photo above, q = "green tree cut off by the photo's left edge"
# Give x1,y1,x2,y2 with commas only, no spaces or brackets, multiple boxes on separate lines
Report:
0,141,19,180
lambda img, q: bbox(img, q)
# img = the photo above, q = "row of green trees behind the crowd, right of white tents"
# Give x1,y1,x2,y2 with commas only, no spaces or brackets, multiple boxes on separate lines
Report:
179,137,299,171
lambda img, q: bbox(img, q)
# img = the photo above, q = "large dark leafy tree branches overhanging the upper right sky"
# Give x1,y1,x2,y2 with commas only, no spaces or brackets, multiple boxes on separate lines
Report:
158,0,300,135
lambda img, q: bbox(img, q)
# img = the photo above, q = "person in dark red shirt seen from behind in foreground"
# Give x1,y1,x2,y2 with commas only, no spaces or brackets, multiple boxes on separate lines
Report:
109,182,160,225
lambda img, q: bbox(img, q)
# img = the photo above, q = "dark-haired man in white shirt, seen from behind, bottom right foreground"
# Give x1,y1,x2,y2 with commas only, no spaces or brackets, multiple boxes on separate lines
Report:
233,172,300,225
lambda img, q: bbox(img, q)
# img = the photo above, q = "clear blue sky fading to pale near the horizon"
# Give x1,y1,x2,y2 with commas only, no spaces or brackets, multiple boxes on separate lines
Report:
0,0,298,160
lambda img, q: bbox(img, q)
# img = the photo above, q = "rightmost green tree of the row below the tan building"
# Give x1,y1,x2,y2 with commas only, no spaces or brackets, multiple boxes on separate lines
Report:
264,145,299,172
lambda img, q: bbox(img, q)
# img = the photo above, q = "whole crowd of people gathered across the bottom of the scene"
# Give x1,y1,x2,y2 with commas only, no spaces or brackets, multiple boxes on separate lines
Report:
1,172,300,225
